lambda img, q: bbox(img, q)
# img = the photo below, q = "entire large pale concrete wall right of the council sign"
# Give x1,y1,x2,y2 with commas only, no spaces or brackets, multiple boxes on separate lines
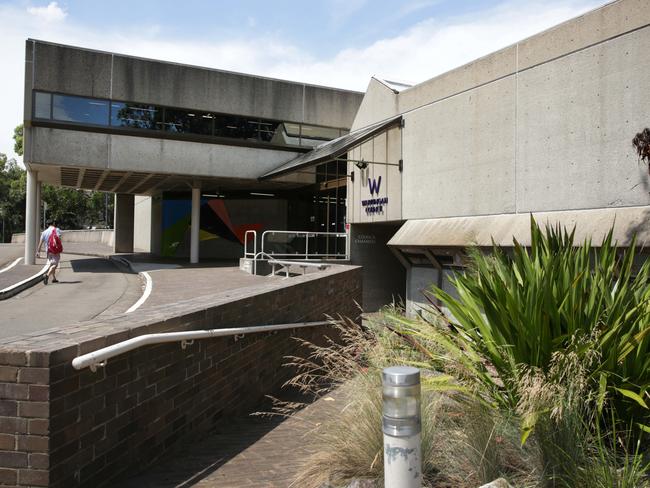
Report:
348,0,650,222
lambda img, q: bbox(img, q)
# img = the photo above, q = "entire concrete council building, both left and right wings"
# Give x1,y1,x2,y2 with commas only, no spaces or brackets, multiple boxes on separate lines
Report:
20,0,650,310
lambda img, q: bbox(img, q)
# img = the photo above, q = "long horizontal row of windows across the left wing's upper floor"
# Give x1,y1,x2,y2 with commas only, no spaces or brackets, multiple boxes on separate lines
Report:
34,91,348,147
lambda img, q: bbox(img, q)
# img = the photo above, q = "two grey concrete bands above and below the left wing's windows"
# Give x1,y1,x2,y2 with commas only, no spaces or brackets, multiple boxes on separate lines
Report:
25,39,362,191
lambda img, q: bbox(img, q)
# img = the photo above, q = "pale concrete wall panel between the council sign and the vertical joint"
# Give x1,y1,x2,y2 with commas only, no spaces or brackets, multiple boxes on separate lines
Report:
403,77,516,219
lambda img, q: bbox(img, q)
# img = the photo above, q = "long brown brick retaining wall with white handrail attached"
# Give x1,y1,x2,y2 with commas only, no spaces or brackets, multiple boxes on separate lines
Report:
0,266,361,488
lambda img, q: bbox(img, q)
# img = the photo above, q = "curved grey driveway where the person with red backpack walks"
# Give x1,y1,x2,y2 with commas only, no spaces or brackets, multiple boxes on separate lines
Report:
0,253,142,338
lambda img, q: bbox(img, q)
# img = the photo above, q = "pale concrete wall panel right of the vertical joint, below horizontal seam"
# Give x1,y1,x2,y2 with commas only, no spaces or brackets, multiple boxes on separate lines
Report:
517,28,650,212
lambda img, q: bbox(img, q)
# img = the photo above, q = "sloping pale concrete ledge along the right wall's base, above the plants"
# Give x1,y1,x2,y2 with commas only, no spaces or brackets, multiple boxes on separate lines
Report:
388,206,650,248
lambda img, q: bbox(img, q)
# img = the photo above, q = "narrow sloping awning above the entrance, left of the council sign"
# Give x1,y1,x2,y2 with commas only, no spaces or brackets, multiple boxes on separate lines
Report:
260,115,402,180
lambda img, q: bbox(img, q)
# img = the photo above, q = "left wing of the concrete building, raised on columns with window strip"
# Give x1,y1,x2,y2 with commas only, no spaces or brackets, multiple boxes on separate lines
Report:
24,39,363,263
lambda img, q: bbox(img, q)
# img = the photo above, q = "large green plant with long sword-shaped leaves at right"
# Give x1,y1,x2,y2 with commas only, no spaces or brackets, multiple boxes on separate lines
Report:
434,219,650,434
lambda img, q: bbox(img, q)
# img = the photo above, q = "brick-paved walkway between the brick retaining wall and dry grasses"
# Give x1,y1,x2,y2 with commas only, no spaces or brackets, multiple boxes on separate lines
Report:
111,390,346,488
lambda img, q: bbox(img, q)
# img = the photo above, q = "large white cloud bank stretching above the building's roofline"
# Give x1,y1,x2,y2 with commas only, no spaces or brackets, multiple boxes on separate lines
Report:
0,0,603,164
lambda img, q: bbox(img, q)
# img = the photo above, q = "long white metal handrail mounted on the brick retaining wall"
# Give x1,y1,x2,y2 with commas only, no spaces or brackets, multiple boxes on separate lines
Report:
72,320,331,372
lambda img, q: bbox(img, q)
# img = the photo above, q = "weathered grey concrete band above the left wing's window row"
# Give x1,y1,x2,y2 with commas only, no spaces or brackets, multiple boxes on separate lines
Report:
25,40,363,127
